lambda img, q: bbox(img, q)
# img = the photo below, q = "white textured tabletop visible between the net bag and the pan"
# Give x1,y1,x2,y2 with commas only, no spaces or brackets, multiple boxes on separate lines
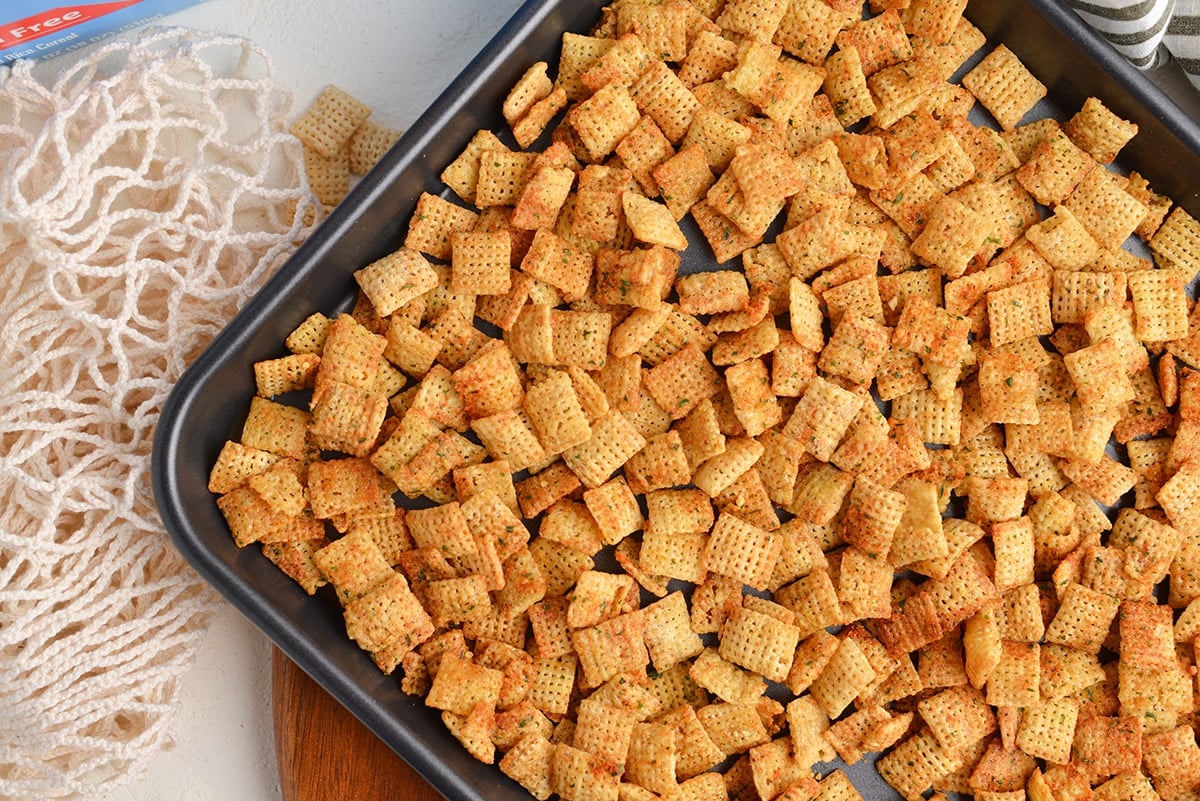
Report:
85,0,521,801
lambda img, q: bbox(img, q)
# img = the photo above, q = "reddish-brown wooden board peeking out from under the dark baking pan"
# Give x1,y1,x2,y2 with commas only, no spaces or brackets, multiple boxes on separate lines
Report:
271,648,444,801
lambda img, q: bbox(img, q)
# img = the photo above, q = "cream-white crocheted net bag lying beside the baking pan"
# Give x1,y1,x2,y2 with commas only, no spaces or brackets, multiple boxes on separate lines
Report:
0,30,314,800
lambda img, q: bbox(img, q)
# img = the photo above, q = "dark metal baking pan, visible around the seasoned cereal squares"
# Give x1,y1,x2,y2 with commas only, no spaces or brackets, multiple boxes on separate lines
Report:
154,0,1200,801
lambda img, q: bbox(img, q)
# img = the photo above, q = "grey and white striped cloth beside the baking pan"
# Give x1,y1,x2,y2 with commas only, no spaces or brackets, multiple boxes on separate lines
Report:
1067,0,1200,88
